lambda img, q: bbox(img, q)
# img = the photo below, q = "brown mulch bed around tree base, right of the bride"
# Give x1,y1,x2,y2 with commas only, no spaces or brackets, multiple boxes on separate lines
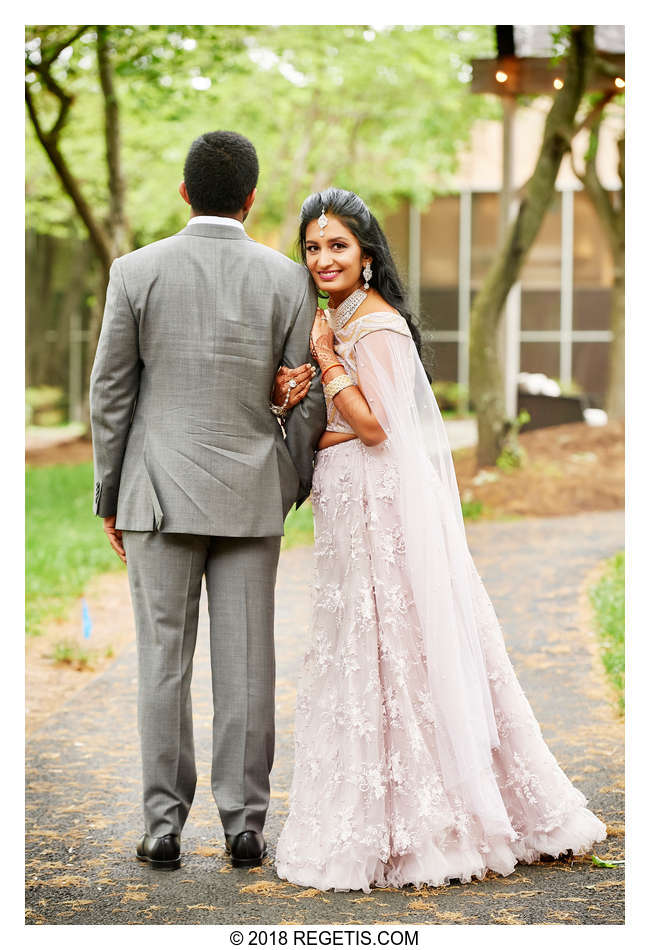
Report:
454,421,625,518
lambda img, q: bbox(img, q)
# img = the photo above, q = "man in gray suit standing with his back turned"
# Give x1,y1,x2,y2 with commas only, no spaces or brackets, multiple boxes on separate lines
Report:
90,132,325,870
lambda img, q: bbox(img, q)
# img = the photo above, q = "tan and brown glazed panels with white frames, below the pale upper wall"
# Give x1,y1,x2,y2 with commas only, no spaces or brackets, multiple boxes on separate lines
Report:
385,191,613,405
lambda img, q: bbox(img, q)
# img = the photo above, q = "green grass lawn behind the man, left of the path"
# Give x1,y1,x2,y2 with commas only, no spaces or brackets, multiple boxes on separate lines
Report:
26,462,314,635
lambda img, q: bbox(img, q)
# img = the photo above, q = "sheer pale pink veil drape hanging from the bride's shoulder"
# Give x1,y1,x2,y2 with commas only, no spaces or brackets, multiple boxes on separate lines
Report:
355,329,516,840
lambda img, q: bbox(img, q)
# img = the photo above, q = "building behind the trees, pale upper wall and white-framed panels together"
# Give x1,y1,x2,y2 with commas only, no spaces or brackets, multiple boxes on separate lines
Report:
385,97,623,405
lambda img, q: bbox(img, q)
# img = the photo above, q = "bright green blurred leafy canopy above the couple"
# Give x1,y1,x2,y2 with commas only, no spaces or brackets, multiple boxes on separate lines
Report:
26,25,497,249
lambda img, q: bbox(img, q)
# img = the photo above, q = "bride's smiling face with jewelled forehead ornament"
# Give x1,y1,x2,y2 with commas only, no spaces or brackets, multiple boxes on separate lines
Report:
305,214,366,306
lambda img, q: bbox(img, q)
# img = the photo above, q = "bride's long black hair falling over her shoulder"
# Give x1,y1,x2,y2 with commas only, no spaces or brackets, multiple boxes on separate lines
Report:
298,188,421,353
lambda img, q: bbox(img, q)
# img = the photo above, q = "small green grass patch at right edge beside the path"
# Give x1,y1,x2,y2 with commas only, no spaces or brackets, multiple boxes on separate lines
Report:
589,551,625,712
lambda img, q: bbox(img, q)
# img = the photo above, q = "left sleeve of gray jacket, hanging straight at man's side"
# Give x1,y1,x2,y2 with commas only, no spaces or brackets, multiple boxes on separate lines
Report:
90,260,141,518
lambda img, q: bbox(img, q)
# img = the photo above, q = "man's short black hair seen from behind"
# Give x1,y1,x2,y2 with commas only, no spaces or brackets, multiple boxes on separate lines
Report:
183,132,259,214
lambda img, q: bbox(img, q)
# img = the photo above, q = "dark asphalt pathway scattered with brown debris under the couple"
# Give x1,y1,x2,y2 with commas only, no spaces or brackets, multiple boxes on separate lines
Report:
26,512,624,926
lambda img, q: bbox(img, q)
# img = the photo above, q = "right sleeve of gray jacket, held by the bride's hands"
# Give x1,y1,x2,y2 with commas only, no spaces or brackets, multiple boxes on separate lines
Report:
282,272,327,508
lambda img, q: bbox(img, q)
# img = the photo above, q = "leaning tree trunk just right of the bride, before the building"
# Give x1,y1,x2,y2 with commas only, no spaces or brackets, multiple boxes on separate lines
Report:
470,26,594,465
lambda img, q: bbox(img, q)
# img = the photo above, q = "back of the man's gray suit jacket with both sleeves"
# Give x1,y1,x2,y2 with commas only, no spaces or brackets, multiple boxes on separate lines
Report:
90,224,326,537
